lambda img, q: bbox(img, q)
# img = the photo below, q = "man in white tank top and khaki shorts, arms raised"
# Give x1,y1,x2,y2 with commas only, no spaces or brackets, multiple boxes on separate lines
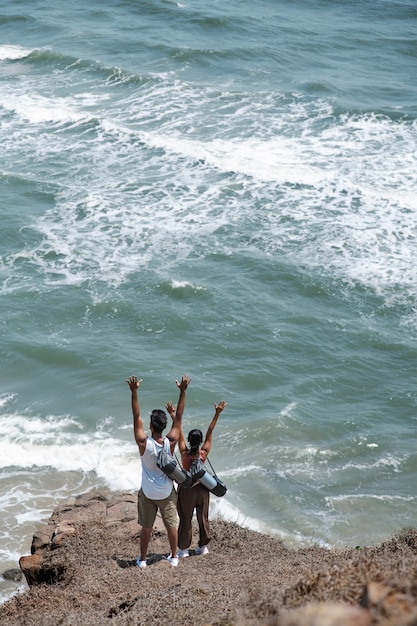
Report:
126,375,191,568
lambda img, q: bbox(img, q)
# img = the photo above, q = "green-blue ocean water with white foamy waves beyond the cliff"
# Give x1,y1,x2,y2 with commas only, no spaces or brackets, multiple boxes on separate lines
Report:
0,0,417,601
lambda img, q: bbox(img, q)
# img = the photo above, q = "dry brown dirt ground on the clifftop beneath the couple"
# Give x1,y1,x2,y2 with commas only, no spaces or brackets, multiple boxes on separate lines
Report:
0,520,417,626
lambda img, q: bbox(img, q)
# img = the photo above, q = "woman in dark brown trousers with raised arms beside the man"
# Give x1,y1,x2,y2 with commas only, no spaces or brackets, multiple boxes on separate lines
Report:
167,400,226,558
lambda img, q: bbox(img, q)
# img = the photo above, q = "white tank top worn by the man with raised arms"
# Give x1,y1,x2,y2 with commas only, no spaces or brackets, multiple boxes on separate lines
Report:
140,437,173,500
